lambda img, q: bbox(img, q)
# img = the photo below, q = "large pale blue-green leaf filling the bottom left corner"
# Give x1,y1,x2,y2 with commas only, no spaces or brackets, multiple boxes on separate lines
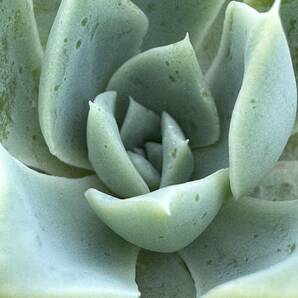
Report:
0,147,139,298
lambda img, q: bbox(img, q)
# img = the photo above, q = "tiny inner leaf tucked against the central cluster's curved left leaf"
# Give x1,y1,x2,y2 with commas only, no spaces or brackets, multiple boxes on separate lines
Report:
127,151,160,191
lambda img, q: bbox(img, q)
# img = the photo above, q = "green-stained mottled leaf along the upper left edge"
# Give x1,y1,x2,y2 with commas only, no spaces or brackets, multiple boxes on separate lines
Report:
0,0,83,176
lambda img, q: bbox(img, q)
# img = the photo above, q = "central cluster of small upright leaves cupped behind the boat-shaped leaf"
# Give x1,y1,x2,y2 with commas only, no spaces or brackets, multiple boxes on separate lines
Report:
87,91,194,198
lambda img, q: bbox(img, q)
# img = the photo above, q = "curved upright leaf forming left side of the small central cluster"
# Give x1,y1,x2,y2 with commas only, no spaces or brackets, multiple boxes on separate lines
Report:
87,91,149,197
